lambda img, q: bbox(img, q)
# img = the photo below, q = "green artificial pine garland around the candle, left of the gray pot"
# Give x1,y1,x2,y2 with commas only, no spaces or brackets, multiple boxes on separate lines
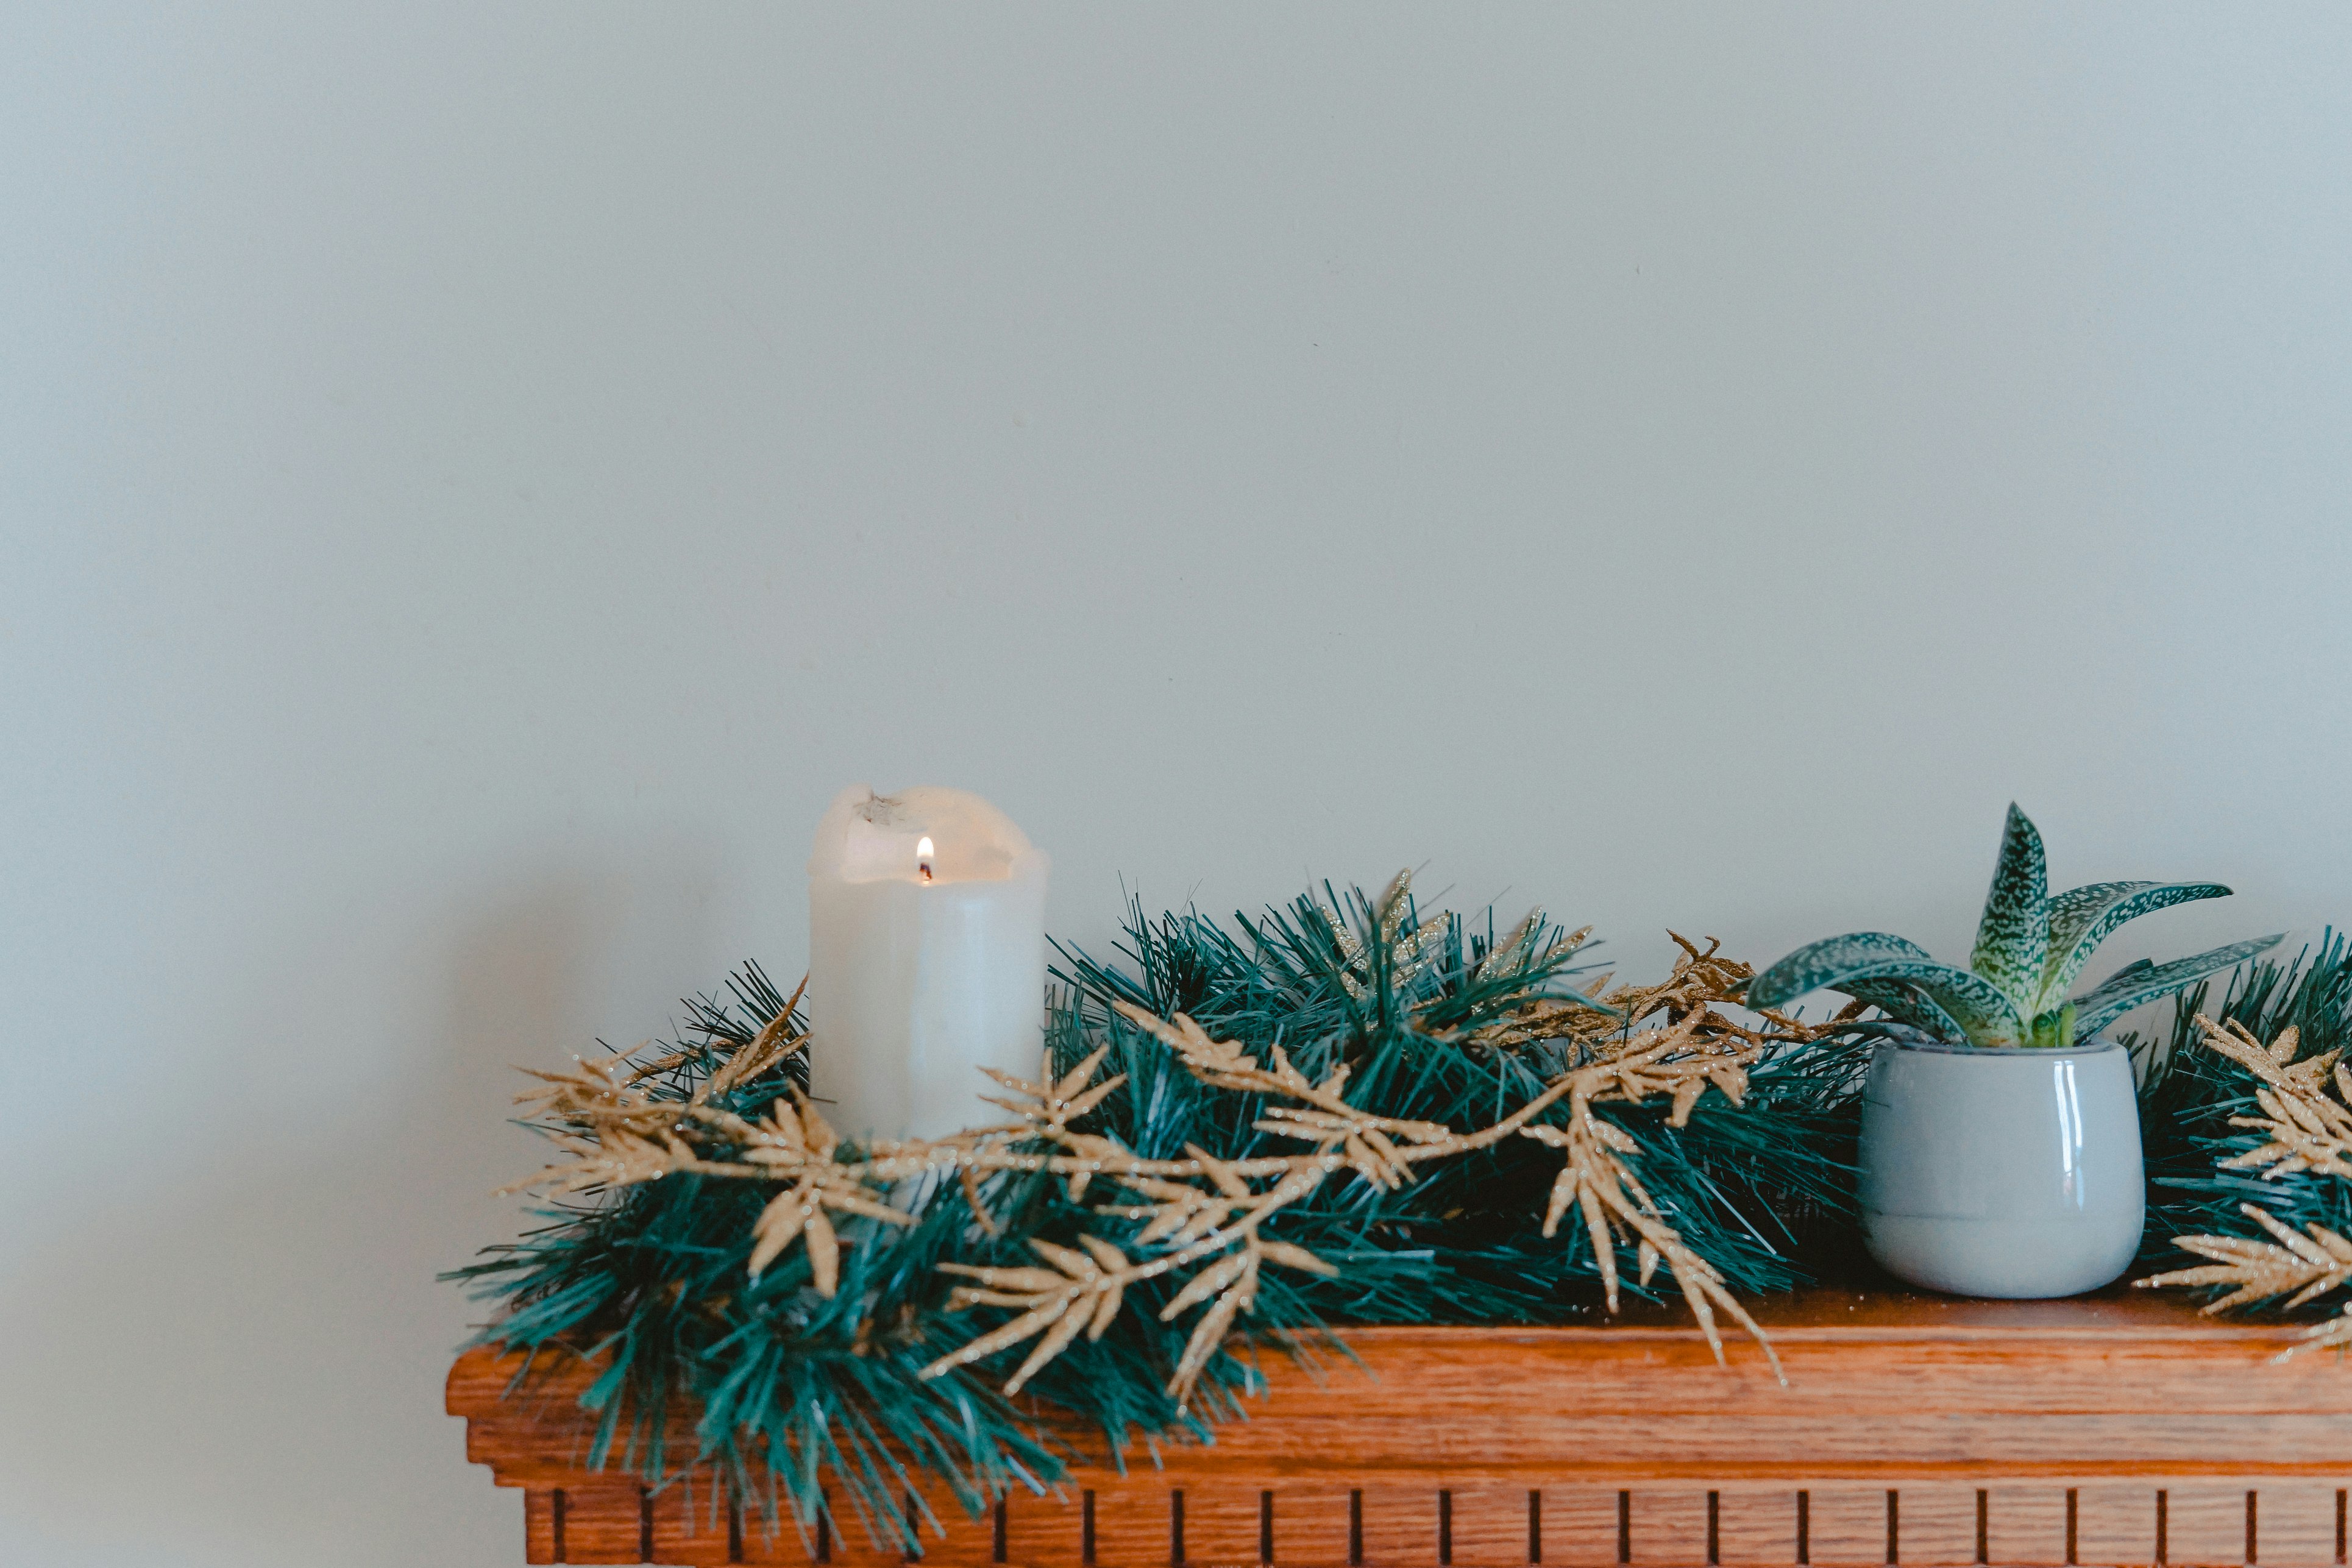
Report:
452,884,1863,1544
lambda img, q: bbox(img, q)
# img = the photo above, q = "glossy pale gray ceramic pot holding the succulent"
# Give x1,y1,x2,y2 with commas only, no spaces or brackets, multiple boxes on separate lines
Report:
1860,1041,2147,1296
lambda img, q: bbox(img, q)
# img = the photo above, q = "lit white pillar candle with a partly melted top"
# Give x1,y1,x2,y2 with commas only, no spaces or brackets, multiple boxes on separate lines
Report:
809,785,1046,1138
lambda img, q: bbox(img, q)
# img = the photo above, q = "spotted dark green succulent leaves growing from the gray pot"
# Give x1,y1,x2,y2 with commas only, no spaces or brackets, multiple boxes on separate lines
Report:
1747,804,2279,1046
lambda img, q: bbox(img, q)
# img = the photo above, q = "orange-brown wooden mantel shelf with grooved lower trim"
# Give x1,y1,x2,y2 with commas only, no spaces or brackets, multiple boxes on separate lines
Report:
449,1291,2352,1568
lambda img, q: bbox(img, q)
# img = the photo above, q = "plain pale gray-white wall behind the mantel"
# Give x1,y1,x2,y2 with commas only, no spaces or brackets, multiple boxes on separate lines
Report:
0,0,2352,1568
